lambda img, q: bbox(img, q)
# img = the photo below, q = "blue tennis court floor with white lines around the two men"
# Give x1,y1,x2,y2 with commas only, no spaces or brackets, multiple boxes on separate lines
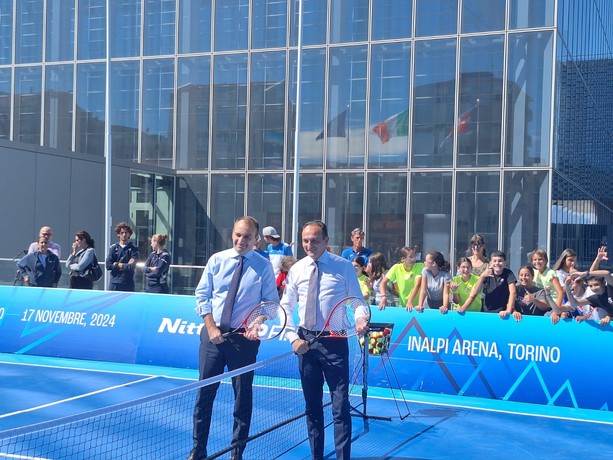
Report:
0,354,613,460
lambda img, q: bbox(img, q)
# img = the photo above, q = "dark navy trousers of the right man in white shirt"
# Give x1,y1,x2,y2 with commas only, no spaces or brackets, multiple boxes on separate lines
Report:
298,329,351,460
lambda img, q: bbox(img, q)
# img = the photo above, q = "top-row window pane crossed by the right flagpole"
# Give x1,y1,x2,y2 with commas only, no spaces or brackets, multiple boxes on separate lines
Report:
290,0,328,46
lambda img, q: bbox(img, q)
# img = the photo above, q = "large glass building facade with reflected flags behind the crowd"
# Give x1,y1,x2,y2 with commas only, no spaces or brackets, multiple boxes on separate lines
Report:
0,0,613,292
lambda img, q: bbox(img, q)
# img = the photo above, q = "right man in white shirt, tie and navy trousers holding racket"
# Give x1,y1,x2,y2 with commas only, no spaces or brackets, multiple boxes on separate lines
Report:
281,221,367,460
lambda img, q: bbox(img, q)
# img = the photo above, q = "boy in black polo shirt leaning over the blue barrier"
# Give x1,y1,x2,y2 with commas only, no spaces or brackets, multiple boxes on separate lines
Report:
461,251,517,318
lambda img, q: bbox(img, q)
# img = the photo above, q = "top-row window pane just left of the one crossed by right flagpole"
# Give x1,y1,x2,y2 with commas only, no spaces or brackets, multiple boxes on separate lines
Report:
251,0,287,48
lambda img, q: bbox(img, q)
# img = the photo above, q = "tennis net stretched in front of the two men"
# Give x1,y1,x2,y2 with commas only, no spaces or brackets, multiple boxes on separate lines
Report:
0,340,359,460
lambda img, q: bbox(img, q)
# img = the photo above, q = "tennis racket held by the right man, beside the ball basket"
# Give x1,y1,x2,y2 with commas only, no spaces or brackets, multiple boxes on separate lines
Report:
309,297,370,345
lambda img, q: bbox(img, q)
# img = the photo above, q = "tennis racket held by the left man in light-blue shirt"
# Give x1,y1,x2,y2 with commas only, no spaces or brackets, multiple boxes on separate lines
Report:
223,302,287,340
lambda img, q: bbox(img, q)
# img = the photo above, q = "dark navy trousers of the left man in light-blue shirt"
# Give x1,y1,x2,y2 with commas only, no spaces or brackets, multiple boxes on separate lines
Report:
193,327,260,458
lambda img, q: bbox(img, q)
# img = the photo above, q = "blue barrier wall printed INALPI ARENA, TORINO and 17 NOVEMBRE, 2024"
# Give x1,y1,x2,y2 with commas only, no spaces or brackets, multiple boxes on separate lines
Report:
0,286,613,411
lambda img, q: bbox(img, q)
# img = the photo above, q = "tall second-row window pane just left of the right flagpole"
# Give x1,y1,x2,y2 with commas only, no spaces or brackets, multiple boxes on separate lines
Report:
249,52,285,169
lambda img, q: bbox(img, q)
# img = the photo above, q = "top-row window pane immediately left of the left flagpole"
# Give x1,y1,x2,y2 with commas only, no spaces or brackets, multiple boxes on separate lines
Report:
77,0,106,59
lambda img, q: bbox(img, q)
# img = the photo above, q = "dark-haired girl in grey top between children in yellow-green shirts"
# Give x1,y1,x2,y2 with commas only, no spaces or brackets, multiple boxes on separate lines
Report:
414,251,451,314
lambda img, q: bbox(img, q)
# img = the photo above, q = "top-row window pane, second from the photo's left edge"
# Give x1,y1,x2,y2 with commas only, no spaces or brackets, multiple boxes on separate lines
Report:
15,0,44,64
